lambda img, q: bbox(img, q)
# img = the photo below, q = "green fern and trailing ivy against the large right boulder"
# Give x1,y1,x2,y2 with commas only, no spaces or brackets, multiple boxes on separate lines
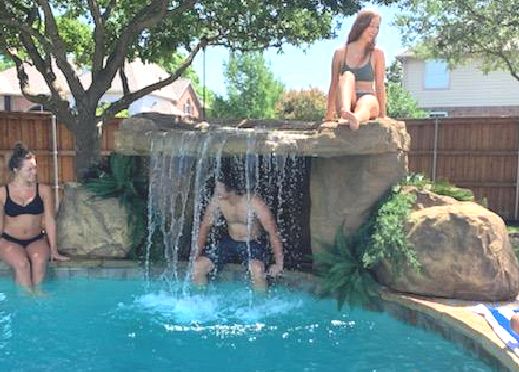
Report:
315,174,484,308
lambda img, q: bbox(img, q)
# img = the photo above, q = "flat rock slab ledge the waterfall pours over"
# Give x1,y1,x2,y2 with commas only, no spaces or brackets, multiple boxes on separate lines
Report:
115,118,410,157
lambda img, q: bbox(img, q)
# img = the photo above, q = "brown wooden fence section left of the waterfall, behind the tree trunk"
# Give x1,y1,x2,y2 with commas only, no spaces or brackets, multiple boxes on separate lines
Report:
0,111,120,188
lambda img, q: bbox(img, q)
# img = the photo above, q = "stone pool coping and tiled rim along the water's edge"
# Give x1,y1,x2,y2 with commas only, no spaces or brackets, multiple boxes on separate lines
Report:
0,258,519,371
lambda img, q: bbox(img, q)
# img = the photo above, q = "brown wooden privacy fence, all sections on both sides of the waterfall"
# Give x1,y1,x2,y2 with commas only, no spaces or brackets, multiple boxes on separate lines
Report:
0,111,519,220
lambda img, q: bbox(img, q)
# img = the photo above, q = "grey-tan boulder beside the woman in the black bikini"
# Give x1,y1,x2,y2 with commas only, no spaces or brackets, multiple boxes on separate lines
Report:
57,183,131,258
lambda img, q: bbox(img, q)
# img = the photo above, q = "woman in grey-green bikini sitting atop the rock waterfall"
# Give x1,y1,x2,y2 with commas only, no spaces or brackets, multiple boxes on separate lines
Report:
325,10,386,130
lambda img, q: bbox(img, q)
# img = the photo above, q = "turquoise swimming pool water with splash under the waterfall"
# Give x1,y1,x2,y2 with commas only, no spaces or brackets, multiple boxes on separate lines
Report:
0,278,491,372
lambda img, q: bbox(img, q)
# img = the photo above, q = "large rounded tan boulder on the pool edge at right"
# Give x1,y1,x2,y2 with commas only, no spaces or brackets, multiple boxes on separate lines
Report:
376,191,519,301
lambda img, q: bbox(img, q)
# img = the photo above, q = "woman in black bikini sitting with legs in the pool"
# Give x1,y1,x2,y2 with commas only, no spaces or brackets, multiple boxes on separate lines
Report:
0,144,68,289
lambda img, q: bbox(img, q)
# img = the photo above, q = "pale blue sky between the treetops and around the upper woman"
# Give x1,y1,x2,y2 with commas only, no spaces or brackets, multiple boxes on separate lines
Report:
193,6,403,95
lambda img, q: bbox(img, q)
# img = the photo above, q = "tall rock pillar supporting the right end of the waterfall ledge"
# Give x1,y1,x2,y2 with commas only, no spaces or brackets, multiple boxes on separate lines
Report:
310,119,409,252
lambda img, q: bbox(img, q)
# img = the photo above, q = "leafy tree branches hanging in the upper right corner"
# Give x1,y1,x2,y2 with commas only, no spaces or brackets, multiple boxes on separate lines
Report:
396,0,519,81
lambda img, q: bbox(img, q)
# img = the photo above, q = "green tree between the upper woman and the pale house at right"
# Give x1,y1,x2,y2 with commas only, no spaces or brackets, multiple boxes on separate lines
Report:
386,60,427,119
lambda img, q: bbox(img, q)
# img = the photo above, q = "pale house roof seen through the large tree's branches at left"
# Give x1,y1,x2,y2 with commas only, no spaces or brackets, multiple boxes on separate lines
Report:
0,60,191,101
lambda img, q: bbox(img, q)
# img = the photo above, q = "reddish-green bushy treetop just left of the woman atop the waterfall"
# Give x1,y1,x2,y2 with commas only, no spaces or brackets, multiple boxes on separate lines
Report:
277,88,327,120
